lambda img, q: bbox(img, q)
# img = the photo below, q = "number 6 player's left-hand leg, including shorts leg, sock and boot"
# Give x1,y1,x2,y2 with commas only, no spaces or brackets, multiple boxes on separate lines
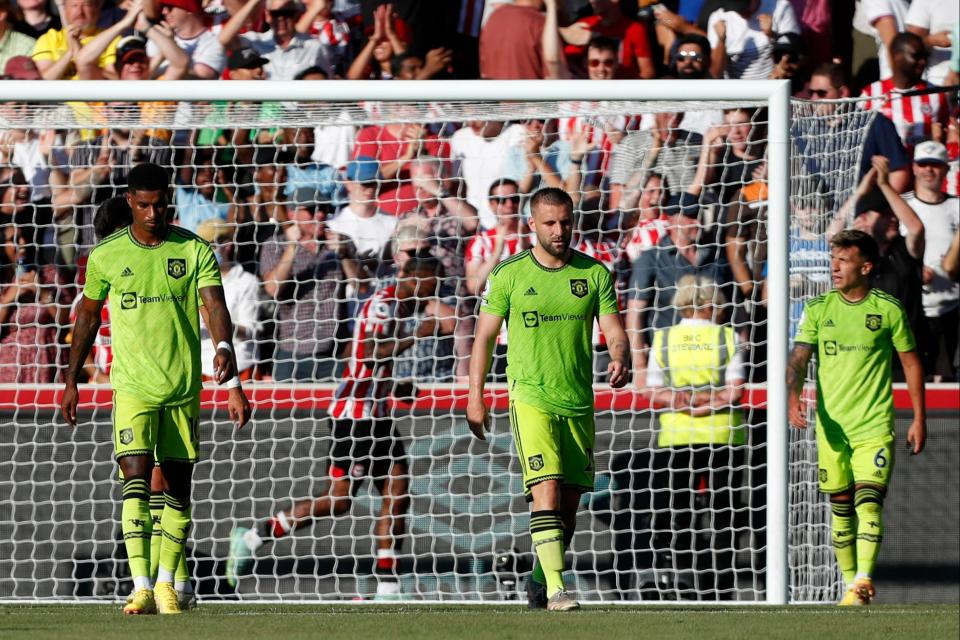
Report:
817,426,861,606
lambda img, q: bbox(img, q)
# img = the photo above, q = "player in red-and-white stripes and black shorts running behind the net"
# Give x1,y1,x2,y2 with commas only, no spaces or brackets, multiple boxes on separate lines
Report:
227,257,456,596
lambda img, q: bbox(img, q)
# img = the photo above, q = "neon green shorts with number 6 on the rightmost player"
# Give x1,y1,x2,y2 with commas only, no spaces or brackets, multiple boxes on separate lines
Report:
817,427,895,494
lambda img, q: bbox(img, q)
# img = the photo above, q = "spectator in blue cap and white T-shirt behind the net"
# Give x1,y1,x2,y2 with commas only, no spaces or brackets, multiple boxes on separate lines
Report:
327,157,397,284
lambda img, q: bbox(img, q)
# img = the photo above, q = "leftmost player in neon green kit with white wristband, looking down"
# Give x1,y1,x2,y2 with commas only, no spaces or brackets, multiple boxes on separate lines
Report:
60,163,250,614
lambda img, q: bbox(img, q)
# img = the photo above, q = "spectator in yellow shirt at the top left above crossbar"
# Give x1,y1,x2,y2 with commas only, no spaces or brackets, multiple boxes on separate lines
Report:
33,0,120,80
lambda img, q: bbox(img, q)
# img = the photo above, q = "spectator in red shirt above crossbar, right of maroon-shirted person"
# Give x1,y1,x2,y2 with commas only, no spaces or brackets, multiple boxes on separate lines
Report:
560,0,656,80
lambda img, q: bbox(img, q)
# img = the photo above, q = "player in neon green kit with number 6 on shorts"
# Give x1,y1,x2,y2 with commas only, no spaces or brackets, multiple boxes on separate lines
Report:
787,230,927,606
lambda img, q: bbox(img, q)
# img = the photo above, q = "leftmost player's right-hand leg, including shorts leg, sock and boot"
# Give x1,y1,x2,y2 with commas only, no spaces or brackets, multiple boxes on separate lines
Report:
154,397,200,614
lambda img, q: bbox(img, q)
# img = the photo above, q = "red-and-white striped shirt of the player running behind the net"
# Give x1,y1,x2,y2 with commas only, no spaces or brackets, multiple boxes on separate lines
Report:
329,284,397,420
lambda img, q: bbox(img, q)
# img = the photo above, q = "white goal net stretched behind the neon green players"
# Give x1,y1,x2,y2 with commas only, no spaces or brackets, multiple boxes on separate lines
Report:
0,82,870,603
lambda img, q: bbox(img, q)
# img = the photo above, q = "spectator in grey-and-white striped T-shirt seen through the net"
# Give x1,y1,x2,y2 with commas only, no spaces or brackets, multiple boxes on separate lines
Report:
610,112,703,209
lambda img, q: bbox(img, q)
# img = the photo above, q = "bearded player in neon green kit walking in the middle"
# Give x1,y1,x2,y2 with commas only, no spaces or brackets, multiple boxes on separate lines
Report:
467,188,629,611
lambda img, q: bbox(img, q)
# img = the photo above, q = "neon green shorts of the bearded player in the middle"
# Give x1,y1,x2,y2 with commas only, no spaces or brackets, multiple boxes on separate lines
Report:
510,400,594,499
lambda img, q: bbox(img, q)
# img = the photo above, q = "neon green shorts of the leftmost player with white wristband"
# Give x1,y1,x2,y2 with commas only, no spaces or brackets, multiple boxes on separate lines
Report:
113,391,200,462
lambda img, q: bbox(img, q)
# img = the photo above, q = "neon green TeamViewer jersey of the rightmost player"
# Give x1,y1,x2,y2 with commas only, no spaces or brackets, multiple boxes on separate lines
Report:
796,289,916,442
